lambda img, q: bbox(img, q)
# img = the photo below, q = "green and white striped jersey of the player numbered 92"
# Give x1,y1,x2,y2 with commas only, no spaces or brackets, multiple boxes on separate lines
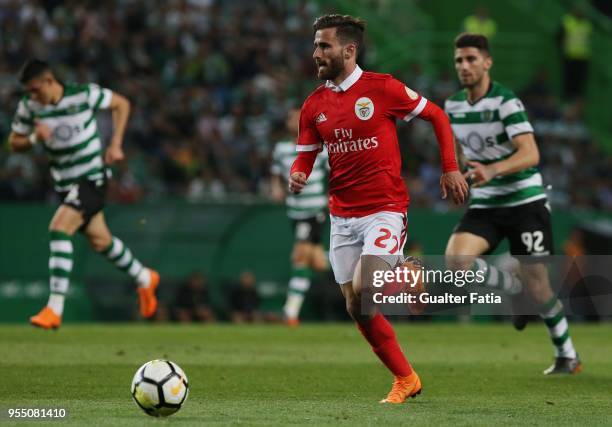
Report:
444,82,546,208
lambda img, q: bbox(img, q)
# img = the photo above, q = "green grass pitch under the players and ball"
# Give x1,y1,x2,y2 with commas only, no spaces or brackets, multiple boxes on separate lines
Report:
0,323,612,426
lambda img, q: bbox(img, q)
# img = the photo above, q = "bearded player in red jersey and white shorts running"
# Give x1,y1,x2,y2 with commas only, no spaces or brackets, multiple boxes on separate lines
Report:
289,15,468,403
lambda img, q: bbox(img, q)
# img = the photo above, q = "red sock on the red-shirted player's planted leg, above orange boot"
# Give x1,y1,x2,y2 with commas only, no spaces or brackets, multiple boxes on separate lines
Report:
357,313,412,377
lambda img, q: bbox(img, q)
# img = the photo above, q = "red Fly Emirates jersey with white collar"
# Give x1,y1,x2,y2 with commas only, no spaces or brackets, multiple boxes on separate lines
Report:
297,67,456,217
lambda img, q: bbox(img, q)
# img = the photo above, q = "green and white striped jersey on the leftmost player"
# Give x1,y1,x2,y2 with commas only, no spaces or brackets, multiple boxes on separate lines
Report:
12,83,112,191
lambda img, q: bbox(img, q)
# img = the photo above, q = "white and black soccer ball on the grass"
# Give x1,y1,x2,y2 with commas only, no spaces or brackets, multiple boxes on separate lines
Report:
132,360,189,417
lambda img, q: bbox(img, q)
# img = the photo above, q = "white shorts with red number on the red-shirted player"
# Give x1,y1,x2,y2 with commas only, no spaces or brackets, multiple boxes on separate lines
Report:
329,212,407,285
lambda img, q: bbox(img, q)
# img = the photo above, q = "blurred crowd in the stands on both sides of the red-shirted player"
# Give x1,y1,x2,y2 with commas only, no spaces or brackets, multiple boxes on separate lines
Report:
0,0,612,210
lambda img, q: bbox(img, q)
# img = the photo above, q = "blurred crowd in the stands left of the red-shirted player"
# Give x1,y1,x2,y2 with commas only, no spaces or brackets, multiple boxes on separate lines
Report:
0,0,315,202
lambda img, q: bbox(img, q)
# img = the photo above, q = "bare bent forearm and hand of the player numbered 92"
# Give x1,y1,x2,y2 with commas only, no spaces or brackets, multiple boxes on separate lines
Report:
464,133,540,186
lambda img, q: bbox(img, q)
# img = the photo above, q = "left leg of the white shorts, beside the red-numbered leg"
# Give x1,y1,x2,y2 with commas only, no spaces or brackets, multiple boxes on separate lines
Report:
329,216,363,285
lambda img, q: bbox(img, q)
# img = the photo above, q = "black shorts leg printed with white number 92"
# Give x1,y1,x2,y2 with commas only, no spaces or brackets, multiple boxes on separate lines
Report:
505,200,554,262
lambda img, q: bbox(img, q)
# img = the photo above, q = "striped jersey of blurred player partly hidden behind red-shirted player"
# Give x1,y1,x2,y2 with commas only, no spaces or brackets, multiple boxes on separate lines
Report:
270,141,329,219
